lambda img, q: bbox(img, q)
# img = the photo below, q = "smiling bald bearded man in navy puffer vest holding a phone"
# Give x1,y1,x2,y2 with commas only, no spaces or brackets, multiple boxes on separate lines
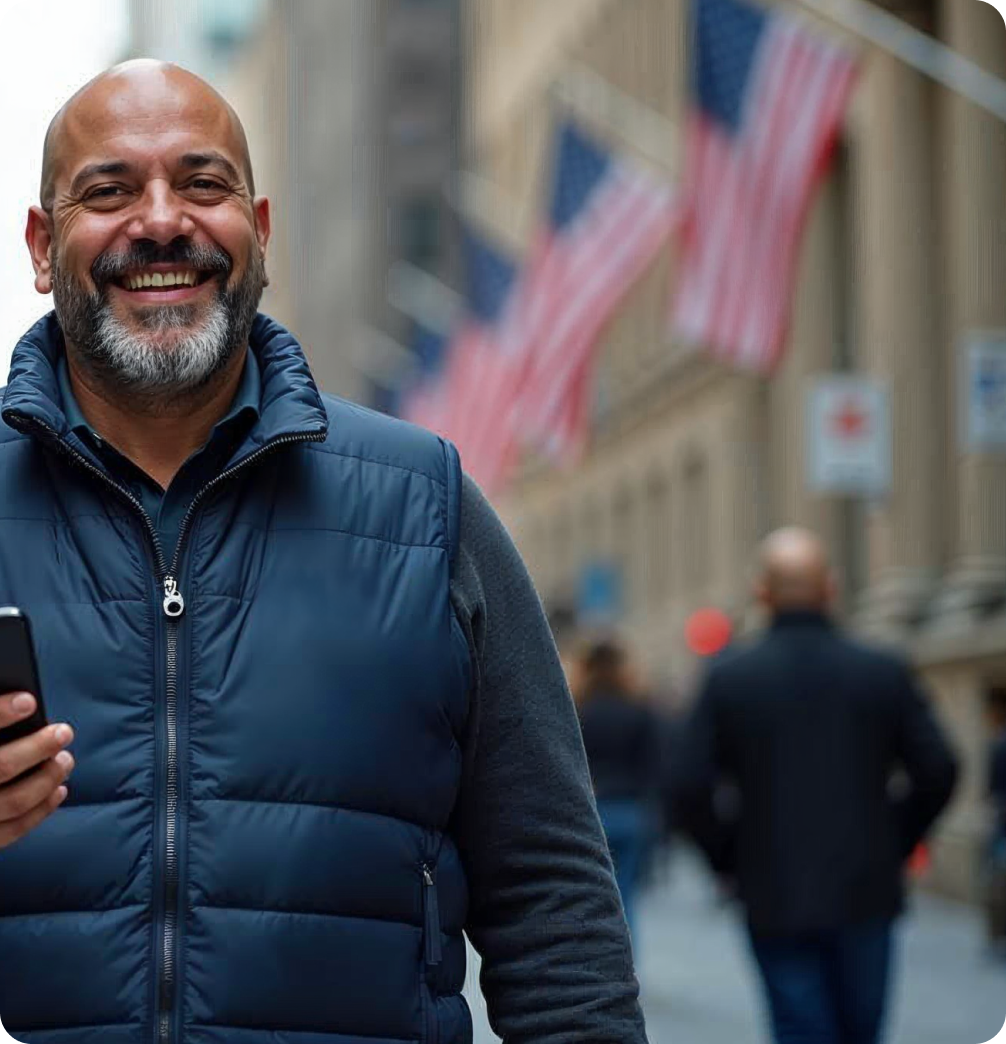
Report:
0,61,645,1044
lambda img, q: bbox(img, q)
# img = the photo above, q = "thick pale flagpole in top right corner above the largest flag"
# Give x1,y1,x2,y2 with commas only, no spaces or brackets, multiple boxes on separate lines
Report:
796,0,1006,122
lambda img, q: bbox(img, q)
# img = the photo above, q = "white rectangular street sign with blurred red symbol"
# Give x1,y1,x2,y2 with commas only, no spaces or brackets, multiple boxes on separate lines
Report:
807,375,891,497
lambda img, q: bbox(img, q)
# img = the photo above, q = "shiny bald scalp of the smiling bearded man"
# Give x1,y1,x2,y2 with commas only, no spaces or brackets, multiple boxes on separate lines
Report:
39,58,255,214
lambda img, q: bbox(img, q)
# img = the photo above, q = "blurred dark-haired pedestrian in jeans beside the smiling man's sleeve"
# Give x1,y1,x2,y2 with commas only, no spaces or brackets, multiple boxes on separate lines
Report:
574,638,662,941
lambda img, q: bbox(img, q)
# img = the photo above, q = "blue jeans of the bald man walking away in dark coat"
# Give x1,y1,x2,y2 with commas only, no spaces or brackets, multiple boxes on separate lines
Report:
751,920,892,1044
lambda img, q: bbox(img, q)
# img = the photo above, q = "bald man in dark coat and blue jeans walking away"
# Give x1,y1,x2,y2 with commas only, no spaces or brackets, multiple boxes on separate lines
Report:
679,528,957,1044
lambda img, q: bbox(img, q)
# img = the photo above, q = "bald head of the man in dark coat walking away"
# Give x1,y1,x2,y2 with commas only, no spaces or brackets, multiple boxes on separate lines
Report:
759,526,834,612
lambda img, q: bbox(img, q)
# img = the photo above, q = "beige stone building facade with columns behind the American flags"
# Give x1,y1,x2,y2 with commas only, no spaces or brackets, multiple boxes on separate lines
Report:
463,0,1006,895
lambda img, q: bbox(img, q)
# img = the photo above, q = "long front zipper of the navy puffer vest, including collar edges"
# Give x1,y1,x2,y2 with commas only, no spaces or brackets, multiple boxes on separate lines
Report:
11,413,326,1044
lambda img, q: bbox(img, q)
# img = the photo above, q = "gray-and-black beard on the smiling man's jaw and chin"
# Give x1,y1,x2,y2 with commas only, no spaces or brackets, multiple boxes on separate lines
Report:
52,250,264,408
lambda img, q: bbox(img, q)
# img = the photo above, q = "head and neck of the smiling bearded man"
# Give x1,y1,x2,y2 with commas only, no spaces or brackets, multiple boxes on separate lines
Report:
27,63,270,487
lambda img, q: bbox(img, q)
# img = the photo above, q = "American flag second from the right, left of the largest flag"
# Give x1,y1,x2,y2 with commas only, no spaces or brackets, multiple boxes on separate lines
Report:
512,121,674,459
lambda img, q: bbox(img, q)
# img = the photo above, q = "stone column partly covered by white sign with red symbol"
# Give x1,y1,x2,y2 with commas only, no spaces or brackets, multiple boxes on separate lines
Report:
853,51,944,637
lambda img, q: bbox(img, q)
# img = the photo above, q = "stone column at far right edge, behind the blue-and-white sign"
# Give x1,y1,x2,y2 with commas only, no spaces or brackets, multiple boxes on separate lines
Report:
934,0,1006,626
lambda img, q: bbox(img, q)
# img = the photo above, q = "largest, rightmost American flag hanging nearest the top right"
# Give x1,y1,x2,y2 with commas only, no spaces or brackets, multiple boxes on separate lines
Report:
672,0,856,373
